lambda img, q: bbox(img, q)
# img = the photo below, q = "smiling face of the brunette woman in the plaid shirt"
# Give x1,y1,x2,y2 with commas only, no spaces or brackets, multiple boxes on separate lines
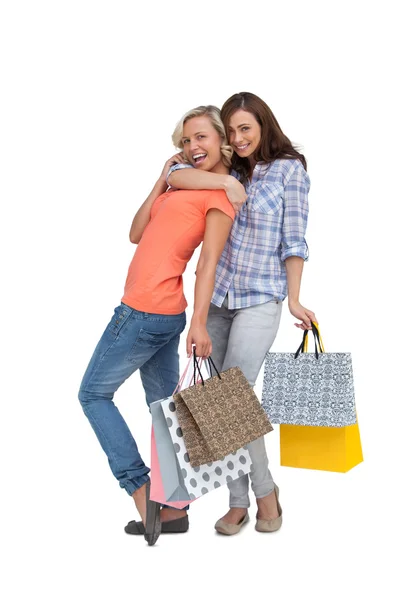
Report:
228,109,261,158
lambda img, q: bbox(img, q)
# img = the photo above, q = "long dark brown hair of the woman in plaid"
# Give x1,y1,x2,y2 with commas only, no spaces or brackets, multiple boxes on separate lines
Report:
221,92,307,182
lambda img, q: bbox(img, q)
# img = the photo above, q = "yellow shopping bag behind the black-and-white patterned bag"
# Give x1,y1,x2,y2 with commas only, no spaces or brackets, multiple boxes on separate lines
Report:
280,323,363,473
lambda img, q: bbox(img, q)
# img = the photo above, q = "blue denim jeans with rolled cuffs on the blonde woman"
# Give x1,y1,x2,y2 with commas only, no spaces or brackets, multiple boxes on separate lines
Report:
79,304,186,495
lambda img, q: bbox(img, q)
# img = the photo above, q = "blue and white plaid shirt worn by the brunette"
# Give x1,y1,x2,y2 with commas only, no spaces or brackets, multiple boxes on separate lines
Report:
167,159,310,308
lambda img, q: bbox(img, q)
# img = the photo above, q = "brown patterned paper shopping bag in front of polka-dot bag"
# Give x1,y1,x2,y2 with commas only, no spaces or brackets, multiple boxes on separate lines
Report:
174,353,273,467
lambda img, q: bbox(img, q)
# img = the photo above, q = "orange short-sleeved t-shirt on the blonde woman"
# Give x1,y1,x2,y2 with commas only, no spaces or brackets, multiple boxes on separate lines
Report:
122,190,235,315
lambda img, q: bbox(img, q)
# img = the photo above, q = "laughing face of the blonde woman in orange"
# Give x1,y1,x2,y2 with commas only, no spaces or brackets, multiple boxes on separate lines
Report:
182,115,227,173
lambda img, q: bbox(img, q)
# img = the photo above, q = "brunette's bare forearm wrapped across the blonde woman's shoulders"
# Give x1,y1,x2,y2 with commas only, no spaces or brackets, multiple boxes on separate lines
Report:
168,169,247,212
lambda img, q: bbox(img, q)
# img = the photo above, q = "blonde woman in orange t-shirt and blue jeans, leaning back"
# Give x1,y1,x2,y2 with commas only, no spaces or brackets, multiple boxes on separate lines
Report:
79,106,237,545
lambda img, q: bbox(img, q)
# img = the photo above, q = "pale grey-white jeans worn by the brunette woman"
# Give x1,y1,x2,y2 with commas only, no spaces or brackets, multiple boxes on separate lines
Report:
207,298,282,508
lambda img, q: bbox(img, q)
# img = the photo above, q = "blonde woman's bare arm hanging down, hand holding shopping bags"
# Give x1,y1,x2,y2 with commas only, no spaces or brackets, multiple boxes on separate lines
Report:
186,208,232,357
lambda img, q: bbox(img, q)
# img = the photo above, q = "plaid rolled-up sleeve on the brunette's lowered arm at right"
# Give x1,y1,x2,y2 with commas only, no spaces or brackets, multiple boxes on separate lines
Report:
281,164,310,261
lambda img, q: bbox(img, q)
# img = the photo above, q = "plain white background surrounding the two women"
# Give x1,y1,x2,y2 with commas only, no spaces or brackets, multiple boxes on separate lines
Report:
0,0,399,600
